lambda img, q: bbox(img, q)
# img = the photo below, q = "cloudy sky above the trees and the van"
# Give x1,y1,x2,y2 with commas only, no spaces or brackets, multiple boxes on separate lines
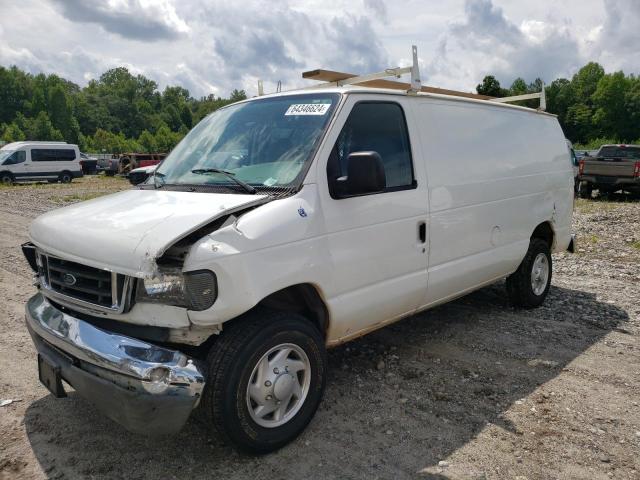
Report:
0,0,640,96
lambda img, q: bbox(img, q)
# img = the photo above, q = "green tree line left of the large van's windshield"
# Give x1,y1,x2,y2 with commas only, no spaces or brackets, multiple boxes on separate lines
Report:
0,66,246,153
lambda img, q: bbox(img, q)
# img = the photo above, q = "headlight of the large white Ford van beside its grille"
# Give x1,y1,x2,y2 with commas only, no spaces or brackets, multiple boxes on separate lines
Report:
136,270,218,310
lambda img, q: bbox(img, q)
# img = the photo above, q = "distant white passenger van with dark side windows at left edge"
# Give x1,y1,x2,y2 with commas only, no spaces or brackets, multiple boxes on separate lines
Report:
0,141,82,185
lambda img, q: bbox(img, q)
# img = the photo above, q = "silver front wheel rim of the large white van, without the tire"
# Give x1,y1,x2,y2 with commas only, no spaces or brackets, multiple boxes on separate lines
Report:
246,343,311,428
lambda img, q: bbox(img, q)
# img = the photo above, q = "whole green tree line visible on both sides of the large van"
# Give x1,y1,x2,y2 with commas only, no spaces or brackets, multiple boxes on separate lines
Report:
0,62,640,153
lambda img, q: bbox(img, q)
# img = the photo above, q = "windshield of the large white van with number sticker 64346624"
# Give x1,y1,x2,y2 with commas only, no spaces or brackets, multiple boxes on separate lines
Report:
156,93,339,192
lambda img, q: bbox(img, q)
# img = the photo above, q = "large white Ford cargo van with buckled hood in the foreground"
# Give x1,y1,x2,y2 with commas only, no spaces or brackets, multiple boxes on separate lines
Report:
23,51,573,452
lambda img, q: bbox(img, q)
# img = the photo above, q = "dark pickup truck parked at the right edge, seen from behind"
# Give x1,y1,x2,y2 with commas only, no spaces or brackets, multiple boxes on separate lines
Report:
578,145,640,198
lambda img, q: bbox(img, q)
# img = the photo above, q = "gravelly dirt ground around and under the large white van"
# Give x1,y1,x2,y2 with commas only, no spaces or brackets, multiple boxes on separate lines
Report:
0,177,640,480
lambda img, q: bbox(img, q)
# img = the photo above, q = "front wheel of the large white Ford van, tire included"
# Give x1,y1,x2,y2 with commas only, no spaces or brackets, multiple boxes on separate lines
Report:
202,310,327,454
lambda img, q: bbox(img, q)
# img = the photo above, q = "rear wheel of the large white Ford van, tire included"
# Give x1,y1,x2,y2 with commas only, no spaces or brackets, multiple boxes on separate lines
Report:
507,238,553,308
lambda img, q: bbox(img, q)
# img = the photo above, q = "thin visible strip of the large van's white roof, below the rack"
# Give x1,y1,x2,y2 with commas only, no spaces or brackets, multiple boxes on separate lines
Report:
243,85,557,117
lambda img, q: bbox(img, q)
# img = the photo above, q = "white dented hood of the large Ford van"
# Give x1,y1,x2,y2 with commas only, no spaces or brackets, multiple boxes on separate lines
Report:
29,189,268,277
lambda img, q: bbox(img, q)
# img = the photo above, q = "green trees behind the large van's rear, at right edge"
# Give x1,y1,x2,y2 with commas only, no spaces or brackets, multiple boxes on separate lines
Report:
476,62,640,149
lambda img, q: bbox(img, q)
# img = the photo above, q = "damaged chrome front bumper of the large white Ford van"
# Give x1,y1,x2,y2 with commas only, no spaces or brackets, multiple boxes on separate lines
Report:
26,293,205,434
